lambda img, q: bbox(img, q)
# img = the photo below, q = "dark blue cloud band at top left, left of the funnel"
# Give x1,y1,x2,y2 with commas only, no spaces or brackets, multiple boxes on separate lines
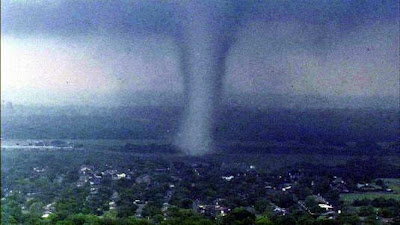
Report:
2,0,180,36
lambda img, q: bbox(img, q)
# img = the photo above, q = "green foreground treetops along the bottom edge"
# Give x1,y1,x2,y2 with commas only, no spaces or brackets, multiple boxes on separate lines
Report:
2,203,400,225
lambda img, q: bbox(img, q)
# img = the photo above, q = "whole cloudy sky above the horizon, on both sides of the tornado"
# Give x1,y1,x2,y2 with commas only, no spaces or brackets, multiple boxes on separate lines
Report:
1,0,400,105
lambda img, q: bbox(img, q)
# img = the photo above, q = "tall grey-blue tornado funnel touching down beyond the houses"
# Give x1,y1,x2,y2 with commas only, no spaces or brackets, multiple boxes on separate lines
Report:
175,1,231,155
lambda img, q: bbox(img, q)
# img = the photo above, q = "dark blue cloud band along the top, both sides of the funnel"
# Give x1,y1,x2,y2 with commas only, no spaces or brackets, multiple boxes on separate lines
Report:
1,0,399,36
